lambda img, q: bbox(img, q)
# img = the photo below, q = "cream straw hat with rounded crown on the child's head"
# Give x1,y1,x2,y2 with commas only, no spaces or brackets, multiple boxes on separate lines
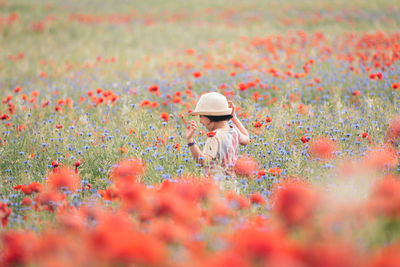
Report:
190,92,232,116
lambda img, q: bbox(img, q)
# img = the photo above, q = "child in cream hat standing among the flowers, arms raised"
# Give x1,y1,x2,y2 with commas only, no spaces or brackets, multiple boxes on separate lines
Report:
186,92,250,178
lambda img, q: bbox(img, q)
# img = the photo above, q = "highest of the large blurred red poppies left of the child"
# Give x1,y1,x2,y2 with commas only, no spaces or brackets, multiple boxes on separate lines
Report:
110,158,145,182
